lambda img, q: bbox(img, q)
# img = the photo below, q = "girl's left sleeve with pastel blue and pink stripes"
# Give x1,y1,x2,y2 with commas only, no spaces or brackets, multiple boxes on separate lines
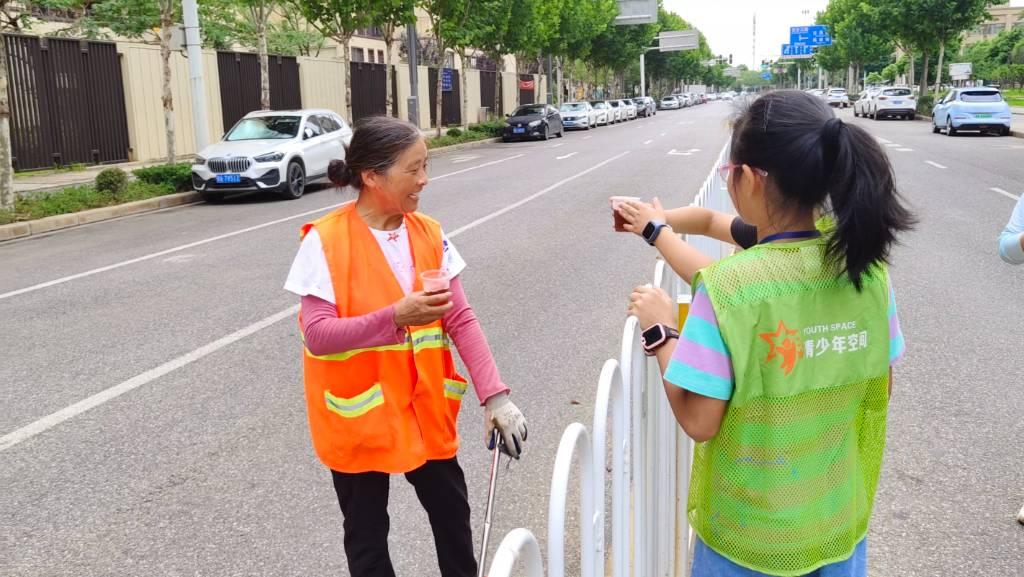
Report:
665,284,733,401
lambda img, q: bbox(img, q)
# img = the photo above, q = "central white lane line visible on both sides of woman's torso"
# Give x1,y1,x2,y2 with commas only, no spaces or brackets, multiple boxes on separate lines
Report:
0,151,630,452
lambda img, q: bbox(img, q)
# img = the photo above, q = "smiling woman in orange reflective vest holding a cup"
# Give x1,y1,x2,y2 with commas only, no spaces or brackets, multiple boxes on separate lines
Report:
285,117,526,577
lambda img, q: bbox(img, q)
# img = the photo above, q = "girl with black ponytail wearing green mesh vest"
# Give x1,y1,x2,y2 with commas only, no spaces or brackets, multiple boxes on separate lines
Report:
623,90,913,577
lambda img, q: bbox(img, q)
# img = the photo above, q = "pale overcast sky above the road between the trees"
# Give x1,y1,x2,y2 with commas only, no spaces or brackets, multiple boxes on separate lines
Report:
664,0,1024,68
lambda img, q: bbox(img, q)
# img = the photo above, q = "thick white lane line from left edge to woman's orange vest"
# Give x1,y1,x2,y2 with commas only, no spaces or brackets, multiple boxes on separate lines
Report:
0,304,299,452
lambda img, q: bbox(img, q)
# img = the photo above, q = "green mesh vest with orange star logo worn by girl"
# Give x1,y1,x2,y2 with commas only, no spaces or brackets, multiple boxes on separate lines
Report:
687,238,889,576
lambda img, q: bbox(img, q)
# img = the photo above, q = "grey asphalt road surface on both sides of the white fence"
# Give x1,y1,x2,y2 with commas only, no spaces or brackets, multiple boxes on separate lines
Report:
0,104,1024,577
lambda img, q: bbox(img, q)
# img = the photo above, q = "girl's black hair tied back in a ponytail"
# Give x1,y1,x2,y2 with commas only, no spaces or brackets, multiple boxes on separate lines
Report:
731,90,914,290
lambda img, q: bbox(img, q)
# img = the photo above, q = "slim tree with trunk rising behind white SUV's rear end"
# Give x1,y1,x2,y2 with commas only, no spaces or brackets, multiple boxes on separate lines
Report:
288,0,377,121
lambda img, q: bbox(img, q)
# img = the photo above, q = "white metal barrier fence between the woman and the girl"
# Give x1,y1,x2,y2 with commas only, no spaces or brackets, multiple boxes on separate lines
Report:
487,138,732,577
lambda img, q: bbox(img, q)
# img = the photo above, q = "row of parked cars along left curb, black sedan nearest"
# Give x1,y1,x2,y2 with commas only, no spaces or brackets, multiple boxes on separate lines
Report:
502,96,657,142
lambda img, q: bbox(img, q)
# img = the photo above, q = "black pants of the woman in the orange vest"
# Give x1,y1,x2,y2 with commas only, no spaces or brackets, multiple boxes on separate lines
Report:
331,457,476,577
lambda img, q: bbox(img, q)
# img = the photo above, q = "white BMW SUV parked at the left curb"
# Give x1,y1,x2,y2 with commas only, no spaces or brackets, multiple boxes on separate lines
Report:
191,109,352,202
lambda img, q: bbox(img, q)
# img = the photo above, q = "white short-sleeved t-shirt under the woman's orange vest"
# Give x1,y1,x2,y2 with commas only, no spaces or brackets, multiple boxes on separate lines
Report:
285,222,466,304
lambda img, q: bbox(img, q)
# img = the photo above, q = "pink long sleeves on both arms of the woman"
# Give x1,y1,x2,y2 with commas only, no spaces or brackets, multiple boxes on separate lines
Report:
302,277,509,405
